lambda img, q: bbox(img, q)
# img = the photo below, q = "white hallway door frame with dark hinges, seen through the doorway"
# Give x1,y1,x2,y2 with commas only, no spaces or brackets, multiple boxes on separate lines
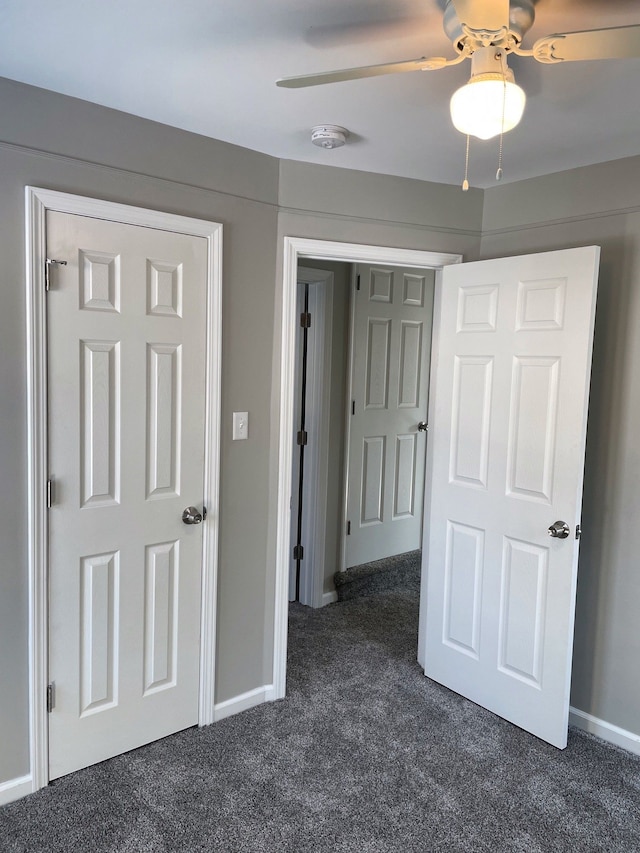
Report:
289,267,333,607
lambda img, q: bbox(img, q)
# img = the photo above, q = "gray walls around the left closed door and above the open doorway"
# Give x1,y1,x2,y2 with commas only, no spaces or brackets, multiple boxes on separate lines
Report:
0,79,482,784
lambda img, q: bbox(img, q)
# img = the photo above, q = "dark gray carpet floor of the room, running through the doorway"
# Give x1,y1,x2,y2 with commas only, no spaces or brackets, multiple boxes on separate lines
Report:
0,589,640,853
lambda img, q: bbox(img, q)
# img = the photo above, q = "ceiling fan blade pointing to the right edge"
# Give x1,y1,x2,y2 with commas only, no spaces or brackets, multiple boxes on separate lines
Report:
532,24,640,62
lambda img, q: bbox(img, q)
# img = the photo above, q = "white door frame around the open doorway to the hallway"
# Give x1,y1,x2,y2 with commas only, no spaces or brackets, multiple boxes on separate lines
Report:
273,237,462,699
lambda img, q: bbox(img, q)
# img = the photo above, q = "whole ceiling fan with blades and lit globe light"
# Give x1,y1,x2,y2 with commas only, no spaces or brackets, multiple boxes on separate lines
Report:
276,0,640,139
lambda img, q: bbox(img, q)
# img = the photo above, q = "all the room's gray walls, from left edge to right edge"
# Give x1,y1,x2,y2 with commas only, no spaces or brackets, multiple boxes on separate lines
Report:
6,70,640,796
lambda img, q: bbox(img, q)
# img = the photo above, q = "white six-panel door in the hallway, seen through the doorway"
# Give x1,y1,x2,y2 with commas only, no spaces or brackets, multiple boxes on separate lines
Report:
345,264,434,568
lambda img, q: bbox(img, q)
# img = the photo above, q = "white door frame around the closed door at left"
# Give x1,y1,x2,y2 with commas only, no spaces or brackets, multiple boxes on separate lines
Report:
25,187,222,791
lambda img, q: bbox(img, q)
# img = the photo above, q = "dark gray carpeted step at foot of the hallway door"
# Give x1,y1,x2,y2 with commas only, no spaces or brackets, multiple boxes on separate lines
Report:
333,549,422,601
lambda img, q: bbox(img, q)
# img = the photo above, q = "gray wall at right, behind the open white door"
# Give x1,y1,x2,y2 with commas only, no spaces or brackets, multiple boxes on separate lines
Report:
482,157,640,734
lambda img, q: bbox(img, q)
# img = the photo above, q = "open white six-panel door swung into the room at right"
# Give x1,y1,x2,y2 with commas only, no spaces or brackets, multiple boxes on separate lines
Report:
419,247,600,748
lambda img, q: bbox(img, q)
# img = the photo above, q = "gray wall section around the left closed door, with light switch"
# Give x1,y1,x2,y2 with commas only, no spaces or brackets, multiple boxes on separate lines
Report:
0,80,278,782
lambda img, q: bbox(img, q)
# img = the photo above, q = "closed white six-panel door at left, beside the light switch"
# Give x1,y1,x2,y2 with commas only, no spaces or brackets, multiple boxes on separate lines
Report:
47,212,207,778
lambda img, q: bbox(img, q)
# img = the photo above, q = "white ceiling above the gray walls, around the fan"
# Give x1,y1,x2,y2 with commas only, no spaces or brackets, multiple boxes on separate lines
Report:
0,0,640,187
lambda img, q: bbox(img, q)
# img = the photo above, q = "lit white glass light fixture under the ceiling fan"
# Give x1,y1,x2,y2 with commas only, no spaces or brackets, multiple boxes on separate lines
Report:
451,68,526,139
